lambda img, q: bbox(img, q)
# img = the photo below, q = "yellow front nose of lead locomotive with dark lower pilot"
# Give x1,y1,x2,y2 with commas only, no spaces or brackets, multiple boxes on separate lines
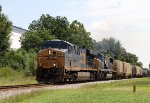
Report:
36,49,64,82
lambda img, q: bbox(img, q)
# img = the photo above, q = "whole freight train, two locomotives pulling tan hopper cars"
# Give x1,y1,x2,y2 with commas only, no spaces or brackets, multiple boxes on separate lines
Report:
36,40,148,83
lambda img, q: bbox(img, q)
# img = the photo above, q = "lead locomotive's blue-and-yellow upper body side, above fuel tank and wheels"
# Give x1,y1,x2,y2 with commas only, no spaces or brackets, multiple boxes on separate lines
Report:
65,49,100,71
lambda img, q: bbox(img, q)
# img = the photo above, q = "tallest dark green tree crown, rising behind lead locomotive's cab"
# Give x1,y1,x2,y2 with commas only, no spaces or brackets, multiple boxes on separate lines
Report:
29,14,69,40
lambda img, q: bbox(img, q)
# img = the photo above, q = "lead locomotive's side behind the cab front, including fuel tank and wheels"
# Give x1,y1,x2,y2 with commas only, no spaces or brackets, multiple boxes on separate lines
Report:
65,49,100,81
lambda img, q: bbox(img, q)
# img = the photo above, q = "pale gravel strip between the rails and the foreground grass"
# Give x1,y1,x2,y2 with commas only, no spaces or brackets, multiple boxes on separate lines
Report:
0,80,125,99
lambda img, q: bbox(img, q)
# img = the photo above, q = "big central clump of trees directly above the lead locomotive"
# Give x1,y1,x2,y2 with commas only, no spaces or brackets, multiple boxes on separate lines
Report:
21,14,93,50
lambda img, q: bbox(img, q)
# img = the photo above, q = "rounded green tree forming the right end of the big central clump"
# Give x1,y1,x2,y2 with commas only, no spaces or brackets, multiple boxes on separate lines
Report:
68,20,94,49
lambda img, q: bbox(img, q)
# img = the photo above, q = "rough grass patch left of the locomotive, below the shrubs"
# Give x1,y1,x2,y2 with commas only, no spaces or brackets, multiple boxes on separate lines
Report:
0,68,37,86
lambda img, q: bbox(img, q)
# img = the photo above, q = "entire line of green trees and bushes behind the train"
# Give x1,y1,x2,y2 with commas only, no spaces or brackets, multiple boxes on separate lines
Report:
0,6,142,75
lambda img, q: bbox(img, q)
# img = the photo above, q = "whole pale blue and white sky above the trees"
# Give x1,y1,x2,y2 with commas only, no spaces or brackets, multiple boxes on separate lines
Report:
0,0,150,68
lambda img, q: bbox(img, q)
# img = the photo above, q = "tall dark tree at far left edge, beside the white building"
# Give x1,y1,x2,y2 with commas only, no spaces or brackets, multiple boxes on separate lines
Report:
0,6,12,57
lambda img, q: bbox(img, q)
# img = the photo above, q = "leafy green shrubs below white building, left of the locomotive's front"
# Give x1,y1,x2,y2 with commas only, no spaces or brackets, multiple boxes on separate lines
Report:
1,49,36,75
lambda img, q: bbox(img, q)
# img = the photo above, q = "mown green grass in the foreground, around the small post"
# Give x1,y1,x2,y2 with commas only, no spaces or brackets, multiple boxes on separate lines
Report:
1,78,150,103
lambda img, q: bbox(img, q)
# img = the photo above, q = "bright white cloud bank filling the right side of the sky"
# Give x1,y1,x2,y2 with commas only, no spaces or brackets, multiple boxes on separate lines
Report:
79,0,150,67
